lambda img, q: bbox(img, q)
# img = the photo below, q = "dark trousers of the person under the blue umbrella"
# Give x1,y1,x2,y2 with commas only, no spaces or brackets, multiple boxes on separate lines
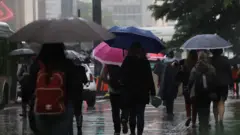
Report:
129,104,146,135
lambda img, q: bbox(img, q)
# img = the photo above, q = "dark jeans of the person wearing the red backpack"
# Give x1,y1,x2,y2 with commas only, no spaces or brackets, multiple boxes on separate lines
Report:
36,104,74,135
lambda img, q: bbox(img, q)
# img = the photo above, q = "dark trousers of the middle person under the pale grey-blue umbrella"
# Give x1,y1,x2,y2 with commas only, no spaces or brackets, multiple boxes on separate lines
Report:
196,99,211,130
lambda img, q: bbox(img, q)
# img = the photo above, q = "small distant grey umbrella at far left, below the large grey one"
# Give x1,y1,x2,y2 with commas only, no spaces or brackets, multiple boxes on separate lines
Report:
9,48,36,56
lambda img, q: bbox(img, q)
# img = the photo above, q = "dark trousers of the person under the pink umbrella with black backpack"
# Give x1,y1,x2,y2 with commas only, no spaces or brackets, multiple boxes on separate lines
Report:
110,94,129,133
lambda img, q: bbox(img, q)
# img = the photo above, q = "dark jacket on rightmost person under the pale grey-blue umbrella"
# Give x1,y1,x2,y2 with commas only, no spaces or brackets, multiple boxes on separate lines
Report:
211,56,233,86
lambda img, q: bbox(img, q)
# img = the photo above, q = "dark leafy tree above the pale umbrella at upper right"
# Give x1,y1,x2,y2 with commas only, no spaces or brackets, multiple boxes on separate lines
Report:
149,0,240,52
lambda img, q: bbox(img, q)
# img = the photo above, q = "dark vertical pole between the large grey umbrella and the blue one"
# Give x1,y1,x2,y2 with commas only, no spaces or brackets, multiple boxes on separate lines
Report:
92,0,102,76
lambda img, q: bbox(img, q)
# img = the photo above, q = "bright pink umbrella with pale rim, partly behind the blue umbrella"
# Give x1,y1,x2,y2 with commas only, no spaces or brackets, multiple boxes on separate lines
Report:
93,42,127,66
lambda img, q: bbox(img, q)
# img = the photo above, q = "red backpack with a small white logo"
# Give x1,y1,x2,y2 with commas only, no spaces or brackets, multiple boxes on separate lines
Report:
34,64,65,115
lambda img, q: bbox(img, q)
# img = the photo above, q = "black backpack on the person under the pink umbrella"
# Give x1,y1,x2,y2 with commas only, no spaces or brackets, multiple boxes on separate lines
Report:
107,65,121,89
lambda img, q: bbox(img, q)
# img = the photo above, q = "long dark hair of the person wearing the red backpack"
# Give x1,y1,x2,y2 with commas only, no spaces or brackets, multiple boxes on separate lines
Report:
37,43,66,82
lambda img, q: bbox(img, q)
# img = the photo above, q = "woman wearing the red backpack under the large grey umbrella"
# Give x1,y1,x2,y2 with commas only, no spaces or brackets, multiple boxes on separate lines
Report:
29,43,82,135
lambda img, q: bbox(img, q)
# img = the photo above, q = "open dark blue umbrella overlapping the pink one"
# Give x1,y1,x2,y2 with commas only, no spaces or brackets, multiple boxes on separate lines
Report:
105,26,165,53
